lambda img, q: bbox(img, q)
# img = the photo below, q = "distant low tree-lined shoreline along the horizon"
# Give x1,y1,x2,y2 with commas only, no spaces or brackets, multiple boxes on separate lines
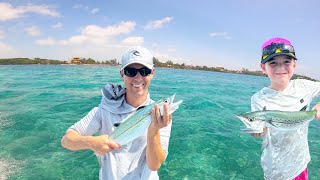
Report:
0,58,319,81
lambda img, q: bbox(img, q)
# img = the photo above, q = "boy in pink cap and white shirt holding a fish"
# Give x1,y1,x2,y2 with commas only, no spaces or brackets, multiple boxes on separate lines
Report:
251,38,320,180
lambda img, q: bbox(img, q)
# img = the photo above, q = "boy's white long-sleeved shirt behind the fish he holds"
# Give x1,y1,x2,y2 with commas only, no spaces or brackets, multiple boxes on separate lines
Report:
251,79,320,179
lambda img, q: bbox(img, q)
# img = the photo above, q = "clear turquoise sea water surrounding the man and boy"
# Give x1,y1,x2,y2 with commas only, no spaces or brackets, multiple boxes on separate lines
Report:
0,65,320,180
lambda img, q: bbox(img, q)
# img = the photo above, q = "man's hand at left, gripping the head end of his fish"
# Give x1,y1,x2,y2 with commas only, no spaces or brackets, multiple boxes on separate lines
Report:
90,135,121,155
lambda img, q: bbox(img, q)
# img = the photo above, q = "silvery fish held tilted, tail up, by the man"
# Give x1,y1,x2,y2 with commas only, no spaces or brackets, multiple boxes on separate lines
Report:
110,94,183,146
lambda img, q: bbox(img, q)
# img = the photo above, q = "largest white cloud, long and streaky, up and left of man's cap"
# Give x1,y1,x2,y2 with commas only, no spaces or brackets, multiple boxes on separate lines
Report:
36,21,136,46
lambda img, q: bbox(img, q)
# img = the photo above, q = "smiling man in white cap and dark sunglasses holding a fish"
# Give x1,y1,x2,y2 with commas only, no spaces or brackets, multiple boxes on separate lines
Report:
61,46,172,179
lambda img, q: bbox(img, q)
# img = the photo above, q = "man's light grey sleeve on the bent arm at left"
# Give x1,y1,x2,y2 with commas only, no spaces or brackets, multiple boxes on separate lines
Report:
67,107,101,136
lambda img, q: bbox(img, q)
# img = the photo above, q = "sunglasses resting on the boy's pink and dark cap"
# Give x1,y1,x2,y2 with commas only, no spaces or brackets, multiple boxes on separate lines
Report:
262,44,295,59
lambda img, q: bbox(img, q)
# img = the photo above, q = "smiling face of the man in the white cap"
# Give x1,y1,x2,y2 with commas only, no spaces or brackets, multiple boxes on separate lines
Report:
120,64,154,98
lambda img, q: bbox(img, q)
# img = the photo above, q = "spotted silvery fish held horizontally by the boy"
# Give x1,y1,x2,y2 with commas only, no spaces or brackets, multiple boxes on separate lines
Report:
237,110,317,133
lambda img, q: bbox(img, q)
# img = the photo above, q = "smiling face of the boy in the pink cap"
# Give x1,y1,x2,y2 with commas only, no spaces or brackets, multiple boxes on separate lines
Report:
261,55,297,86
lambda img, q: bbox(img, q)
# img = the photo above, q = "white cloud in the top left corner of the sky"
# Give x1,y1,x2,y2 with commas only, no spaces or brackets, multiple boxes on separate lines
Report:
0,3,60,21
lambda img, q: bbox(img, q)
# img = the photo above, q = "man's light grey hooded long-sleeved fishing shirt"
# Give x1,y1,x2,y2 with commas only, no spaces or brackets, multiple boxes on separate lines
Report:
68,84,172,179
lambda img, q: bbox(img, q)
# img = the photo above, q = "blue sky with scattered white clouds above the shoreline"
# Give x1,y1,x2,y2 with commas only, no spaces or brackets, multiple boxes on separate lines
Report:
0,0,320,79
